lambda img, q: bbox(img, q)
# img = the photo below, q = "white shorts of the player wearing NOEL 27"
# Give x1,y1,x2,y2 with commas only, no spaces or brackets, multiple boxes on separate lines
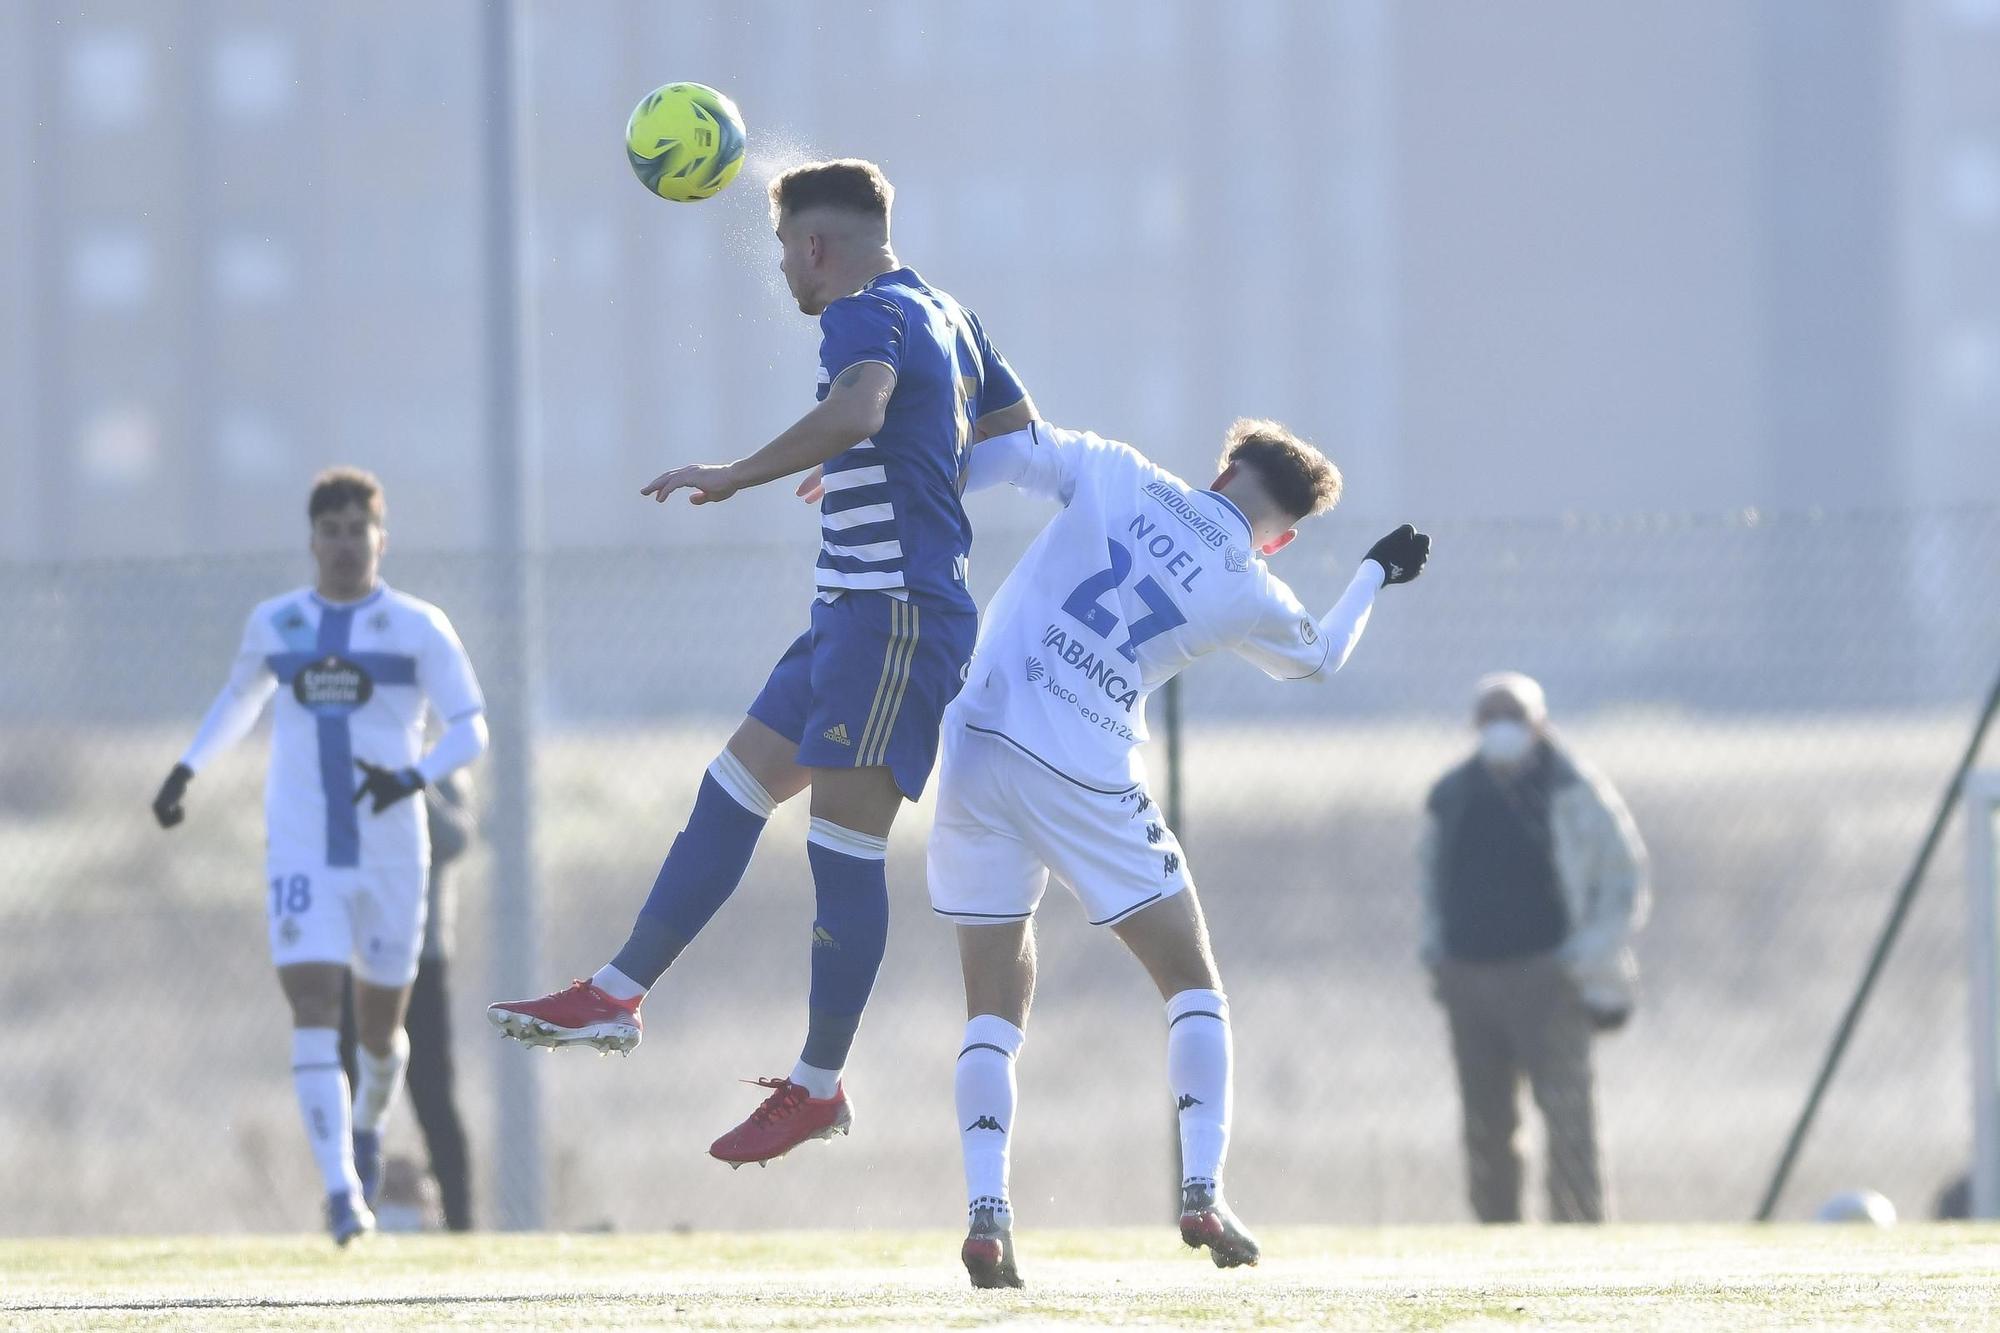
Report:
926,719,1188,925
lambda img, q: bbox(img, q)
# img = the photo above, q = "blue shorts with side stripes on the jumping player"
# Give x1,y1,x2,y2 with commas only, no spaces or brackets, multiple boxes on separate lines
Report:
750,592,980,801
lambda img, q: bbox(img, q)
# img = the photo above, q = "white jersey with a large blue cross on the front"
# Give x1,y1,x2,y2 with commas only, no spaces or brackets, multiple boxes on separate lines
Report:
182,584,486,869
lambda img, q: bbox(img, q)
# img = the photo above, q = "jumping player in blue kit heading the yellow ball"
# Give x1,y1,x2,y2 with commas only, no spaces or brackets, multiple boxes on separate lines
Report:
488,160,1034,1165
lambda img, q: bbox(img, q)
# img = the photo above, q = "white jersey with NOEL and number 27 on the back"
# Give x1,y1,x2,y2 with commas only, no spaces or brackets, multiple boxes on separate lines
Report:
948,422,1380,793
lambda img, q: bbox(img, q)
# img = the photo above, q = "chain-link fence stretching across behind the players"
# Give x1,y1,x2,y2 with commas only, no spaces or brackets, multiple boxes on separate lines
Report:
0,510,2000,1233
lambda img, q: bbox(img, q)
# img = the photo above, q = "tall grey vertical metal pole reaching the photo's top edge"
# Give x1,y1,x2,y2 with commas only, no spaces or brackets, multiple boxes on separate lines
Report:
480,0,548,1231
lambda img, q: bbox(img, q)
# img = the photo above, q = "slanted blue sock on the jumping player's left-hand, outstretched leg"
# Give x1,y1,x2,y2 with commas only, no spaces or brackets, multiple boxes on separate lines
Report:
612,751,774,989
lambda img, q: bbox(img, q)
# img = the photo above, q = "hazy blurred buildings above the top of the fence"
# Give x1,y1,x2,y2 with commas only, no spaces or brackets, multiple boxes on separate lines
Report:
0,0,2000,558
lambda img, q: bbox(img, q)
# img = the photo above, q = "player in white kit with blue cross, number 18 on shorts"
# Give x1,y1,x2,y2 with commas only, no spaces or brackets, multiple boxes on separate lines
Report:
152,468,486,1245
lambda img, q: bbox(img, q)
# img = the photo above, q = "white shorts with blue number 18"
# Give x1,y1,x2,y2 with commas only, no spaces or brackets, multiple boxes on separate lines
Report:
264,863,428,987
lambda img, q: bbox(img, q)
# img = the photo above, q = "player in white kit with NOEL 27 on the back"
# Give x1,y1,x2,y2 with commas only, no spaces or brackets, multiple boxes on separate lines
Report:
928,420,1430,1287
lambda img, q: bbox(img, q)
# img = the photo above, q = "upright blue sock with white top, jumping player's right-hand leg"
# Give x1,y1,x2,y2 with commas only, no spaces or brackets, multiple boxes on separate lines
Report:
798,819,888,1071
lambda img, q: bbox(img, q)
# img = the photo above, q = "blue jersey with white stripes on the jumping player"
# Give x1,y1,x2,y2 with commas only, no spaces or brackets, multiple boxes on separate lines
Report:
818,268,1024,610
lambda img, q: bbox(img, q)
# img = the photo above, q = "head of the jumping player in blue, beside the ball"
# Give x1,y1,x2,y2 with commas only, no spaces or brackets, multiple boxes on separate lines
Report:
770,158,896,314
